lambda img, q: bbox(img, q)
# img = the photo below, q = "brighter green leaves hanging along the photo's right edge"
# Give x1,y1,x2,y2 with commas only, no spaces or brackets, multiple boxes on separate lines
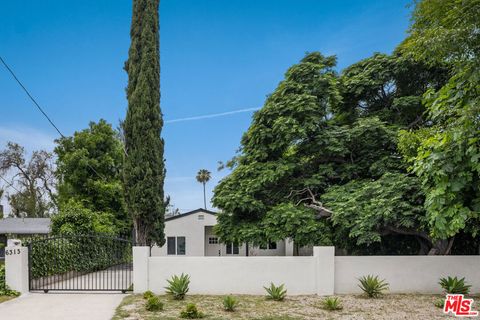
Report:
400,0,480,239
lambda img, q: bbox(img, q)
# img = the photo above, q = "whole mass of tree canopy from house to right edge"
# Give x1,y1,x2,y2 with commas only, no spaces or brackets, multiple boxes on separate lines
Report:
213,0,480,254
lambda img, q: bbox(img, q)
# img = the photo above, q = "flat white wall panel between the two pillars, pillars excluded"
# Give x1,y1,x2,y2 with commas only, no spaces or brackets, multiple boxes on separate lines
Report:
149,257,316,295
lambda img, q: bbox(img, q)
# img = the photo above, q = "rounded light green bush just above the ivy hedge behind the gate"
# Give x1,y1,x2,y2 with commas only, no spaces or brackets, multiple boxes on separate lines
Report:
51,200,117,236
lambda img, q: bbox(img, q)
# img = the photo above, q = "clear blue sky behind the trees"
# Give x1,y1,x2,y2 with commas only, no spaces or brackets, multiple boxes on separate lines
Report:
0,0,411,215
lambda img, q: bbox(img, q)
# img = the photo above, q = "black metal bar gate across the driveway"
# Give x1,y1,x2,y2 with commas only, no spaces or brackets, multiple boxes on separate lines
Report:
28,235,133,293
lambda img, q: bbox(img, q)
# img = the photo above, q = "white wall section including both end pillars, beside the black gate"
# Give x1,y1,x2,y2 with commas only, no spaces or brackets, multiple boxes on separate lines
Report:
133,247,334,295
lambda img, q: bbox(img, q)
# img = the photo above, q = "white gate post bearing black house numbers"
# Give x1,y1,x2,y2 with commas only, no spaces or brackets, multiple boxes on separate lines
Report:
5,240,29,294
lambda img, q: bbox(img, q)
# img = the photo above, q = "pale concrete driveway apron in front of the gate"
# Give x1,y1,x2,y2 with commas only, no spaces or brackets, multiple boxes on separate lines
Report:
0,292,126,320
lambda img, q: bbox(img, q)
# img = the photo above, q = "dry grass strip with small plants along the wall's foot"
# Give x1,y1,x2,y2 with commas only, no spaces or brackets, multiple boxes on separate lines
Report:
112,294,464,320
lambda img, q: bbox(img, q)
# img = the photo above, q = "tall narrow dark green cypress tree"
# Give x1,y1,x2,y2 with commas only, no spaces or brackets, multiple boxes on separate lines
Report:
123,0,165,245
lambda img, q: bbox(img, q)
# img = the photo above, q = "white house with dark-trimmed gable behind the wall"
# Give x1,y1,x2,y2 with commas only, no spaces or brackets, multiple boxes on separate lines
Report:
152,209,293,256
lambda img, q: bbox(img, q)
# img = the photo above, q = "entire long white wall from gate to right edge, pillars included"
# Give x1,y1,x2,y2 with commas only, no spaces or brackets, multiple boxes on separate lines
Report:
134,247,480,295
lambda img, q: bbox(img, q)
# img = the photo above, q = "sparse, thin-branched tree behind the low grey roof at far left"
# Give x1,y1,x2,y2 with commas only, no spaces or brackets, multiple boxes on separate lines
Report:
0,142,56,218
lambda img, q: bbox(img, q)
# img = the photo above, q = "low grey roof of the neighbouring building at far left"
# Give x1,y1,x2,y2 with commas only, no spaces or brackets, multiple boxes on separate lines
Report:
0,218,51,234
